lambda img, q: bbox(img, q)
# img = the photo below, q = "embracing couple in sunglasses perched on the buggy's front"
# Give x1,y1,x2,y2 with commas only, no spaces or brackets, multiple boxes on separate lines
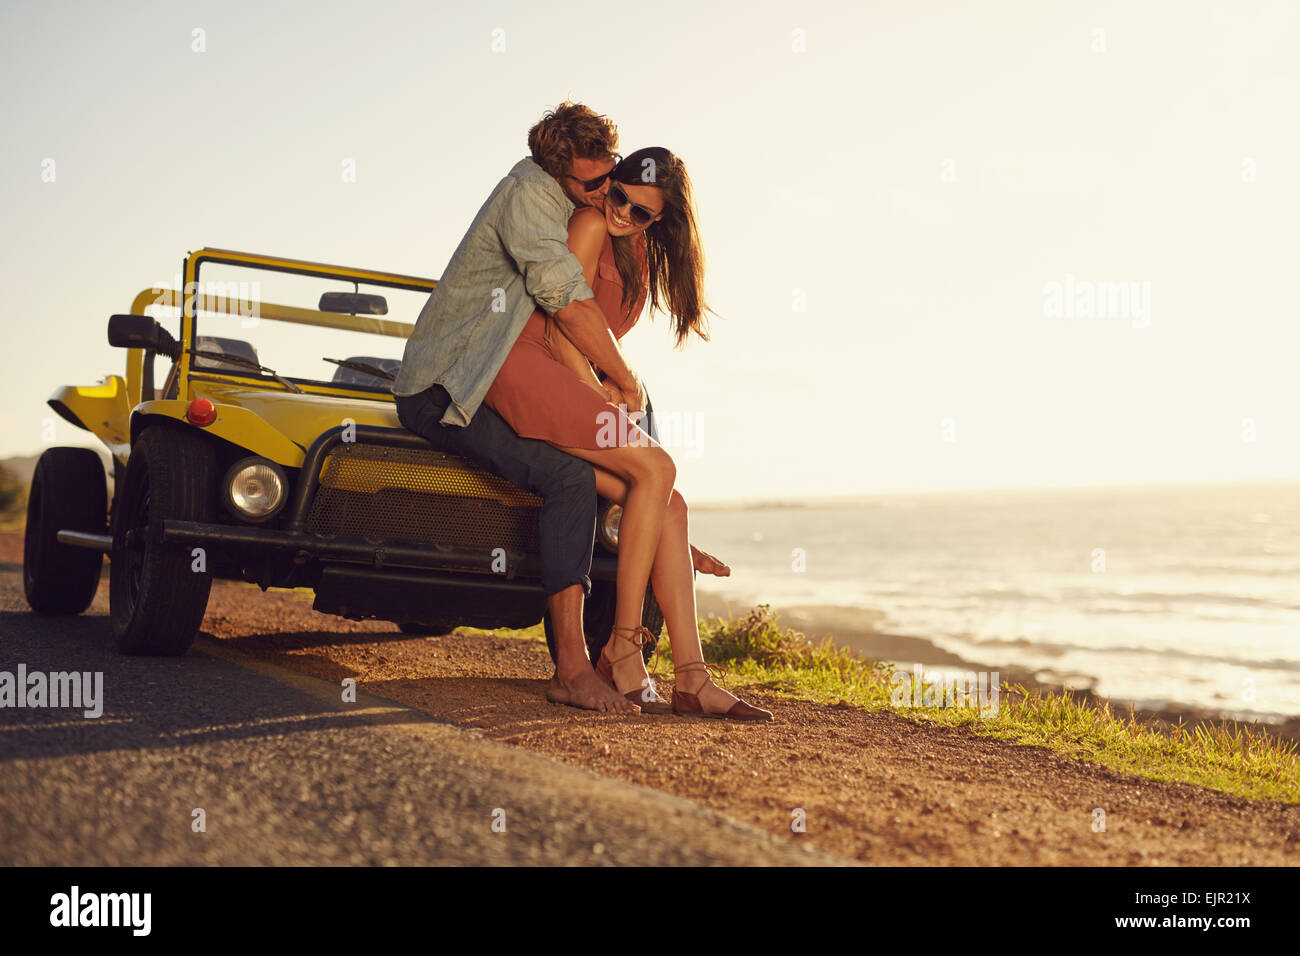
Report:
393,103,772,721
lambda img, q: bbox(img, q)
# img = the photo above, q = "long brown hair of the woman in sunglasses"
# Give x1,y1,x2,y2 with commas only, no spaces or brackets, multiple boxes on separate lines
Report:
610,146,712,346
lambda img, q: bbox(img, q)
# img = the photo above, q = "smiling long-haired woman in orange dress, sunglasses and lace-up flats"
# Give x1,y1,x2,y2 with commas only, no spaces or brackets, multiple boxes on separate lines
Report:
484,147,772,721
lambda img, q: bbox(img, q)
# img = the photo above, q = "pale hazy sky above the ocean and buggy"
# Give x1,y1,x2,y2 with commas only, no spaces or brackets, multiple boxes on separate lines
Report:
0,0,1300,501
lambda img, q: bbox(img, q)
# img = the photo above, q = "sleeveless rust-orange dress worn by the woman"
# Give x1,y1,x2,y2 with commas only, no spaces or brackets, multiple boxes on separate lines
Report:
484,233,646,450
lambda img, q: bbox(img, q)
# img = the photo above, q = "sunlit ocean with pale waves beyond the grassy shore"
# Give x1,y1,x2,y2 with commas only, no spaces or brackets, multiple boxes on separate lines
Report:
690,483,1300,722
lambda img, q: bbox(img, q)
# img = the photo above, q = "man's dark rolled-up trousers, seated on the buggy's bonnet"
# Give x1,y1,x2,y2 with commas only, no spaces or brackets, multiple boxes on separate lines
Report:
395,385,595,597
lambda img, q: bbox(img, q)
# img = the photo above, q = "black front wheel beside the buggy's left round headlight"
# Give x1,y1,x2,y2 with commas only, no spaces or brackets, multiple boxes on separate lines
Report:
109,425,216,657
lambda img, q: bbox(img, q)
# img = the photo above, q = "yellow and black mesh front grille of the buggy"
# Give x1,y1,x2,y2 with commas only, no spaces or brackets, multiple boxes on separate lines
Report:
307,442,542,554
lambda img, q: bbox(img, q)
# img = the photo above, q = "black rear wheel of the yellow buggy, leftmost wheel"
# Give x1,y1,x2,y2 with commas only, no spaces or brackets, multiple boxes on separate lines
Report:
22,447,108,614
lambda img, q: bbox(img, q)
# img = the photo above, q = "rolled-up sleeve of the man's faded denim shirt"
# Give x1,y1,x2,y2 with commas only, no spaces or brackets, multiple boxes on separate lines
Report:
497,179,594,315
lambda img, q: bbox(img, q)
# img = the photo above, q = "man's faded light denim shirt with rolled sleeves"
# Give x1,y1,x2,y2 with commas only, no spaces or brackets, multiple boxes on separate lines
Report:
393,159,593,425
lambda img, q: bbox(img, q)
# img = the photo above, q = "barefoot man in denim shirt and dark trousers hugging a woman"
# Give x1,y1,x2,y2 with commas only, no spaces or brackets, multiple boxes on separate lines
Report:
393,101,645,713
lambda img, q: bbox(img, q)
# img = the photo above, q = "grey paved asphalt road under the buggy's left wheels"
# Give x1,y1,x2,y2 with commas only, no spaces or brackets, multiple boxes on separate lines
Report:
0,563,846,865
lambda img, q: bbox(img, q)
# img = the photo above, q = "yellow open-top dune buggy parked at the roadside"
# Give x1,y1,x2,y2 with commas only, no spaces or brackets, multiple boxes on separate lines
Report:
23,248,663,659
